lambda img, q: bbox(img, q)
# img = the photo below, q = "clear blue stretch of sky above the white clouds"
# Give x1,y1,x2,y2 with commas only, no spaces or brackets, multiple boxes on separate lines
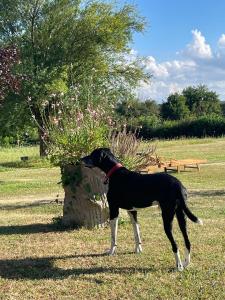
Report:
128,0,225,60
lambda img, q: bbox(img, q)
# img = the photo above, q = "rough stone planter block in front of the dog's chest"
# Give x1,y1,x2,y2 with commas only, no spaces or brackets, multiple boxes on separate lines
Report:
61,165,109,229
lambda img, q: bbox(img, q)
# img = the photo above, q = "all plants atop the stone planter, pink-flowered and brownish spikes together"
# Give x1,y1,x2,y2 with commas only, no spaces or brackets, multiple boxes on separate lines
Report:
28,90,155,170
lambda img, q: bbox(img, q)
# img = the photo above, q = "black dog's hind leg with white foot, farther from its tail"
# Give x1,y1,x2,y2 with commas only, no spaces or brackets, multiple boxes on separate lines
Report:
161,207,183,271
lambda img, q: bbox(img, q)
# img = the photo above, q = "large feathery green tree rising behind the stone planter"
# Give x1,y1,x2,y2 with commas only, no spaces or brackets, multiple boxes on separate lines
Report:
0,0,149,154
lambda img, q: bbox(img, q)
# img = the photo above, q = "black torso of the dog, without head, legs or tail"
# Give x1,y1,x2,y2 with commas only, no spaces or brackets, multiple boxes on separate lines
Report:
108,168,184,209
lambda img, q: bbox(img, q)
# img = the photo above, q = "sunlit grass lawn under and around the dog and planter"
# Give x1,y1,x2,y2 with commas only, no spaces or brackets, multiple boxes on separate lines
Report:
0,138,225,300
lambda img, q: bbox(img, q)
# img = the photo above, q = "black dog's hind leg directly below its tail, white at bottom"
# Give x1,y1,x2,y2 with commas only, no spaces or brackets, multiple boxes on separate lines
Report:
176,208,191,268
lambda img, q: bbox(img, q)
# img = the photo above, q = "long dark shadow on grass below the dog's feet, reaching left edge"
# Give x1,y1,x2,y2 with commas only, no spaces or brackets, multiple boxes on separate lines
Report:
0,254,157,283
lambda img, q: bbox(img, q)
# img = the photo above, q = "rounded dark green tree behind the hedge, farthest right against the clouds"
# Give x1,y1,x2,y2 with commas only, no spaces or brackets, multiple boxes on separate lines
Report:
182,85,221,116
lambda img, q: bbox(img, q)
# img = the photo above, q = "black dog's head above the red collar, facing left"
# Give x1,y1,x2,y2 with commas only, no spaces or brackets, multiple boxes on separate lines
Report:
81,148,118,171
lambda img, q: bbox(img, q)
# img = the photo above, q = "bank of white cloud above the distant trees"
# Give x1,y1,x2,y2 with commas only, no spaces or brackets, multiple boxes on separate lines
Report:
135,30,225,102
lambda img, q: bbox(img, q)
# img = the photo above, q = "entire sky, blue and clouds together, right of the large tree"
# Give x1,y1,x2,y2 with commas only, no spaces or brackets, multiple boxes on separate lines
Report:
119,0,225,102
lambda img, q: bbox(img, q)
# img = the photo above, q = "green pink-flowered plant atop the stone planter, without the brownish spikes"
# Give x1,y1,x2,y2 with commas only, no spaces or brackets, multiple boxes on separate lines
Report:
37,89,112,166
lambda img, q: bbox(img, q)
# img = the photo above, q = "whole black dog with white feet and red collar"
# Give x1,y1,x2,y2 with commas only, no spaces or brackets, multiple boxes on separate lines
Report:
81,148,202,271
